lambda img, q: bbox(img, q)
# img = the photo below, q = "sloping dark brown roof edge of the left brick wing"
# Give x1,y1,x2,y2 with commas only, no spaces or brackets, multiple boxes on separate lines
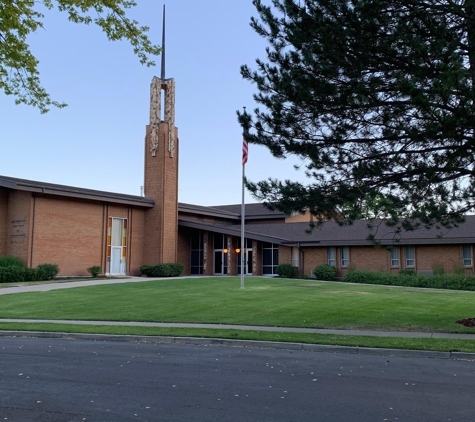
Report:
0,176,155,208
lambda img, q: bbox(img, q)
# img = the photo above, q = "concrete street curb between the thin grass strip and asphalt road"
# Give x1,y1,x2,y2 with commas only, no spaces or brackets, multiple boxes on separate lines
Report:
0,330,475,360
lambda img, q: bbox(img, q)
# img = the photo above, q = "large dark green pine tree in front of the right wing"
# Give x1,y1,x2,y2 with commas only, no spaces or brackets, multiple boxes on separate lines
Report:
242,0,475,234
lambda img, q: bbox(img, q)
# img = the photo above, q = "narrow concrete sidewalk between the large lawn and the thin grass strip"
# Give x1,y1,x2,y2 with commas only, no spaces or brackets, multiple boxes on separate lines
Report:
0,319,475,340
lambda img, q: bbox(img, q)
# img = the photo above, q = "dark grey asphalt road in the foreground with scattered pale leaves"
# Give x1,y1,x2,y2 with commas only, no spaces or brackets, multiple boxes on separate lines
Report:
0,338,475,422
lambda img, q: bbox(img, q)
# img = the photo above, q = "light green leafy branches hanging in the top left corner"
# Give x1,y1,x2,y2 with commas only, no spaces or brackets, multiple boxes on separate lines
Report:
0,0,160,113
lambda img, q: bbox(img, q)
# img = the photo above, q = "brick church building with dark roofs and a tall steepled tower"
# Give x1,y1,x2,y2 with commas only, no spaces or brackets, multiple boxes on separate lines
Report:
0,9,475,276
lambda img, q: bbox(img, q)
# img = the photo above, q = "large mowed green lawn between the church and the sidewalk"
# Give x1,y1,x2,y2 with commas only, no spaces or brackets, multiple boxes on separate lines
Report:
0,277,475,333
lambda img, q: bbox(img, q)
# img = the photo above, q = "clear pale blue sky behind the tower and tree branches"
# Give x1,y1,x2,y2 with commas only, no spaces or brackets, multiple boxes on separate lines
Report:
0,0,306,205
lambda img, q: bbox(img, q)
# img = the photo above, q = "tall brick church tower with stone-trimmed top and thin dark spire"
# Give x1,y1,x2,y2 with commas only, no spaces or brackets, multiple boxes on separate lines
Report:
143,5,178,265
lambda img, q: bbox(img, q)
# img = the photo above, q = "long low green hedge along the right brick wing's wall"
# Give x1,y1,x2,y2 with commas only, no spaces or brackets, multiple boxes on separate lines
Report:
343,270,475,291
